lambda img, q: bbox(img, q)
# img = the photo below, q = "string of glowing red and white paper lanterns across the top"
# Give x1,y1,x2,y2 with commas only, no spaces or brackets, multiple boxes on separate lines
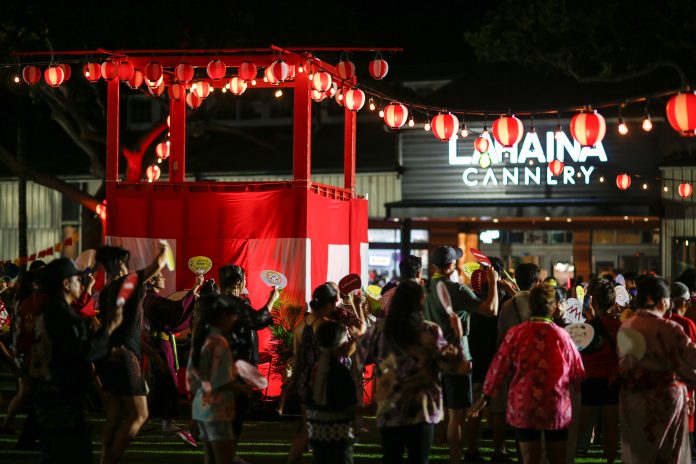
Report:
9,52,696,194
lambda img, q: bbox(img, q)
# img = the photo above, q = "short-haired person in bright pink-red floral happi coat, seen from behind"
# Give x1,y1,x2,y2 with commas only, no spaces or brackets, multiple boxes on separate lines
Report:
469,285,585,464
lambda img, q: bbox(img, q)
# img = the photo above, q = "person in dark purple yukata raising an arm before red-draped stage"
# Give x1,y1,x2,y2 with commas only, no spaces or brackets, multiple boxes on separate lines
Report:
143,272,203,446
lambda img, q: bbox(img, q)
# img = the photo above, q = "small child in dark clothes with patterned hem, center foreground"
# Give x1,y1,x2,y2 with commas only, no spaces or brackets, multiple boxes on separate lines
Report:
306,321,358,464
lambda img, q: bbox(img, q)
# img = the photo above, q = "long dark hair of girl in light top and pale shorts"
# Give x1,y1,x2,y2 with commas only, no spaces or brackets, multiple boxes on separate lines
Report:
191,294,240,369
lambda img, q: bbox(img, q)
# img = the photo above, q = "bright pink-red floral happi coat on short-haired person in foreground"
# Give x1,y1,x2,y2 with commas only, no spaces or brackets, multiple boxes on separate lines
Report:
483,321,585,430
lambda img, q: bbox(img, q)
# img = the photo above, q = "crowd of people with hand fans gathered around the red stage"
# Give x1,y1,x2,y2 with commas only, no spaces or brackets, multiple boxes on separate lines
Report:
0,244,696,464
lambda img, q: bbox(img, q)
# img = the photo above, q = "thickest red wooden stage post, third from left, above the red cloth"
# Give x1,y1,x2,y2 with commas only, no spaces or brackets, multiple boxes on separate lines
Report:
292,57,312,181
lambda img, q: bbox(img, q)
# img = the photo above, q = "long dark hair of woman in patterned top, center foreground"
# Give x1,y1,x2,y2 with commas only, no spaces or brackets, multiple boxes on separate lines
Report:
384,280,424,352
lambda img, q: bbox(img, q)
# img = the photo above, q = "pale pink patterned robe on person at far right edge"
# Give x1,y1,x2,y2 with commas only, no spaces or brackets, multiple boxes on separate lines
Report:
619,309,696,464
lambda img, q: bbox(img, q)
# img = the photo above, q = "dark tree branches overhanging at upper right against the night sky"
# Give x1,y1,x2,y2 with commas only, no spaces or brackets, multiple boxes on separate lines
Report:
465,0,696,86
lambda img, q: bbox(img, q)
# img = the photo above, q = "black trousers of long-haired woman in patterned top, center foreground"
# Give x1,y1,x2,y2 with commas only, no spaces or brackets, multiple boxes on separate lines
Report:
380,422,435,464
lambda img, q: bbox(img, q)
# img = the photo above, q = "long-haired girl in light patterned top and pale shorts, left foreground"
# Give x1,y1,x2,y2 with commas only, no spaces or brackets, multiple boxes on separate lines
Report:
188,295,245,463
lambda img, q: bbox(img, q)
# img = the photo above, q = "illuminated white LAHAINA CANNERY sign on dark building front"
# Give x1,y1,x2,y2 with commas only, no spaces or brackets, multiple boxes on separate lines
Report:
449,131,608,187
